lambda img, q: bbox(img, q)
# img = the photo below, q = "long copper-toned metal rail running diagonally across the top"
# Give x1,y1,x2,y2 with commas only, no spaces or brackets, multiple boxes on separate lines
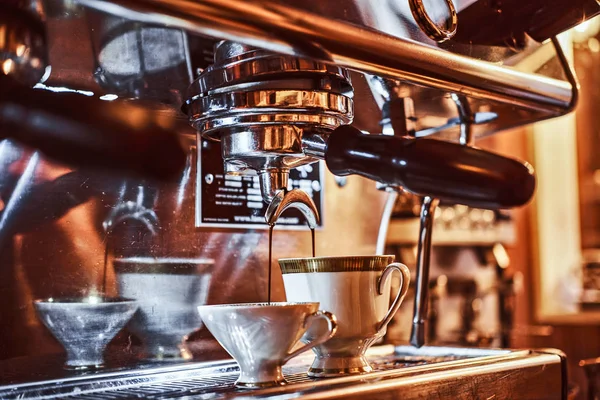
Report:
77,0,572,115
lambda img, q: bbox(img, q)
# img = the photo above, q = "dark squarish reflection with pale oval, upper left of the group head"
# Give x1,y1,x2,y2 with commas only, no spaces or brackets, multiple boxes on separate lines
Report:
86,11,193,107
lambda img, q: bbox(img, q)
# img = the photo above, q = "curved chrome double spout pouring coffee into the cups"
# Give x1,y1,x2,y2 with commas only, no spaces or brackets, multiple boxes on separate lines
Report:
265,189,320,229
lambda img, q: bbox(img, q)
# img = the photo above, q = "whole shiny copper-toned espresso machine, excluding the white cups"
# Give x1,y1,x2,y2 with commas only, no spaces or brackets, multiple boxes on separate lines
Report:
0,0,600,399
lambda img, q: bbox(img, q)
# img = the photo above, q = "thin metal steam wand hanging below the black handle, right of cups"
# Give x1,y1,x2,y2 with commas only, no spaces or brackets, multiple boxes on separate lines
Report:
410,197,439,347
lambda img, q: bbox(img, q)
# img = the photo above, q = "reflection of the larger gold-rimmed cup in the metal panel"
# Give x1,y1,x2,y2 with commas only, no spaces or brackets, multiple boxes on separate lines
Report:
113,257,214,361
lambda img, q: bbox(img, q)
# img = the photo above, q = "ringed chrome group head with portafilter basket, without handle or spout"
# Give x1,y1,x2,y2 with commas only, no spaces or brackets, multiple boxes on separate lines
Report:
190,41,353,202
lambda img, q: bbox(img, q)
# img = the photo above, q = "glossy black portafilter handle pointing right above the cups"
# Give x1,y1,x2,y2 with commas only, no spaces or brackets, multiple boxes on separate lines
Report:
325,125,535,209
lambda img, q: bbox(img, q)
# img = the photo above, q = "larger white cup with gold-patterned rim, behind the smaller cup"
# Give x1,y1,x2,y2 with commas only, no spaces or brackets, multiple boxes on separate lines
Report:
279,256,410,377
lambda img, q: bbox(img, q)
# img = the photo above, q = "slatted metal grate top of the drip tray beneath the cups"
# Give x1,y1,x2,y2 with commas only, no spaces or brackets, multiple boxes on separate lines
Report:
0,346,564,400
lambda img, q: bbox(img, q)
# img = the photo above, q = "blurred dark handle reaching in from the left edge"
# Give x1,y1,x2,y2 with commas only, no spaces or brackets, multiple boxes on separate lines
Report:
0,75,185,180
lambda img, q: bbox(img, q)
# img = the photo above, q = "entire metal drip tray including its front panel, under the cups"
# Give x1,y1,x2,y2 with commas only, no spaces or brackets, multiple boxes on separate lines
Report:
0,346,566,400
